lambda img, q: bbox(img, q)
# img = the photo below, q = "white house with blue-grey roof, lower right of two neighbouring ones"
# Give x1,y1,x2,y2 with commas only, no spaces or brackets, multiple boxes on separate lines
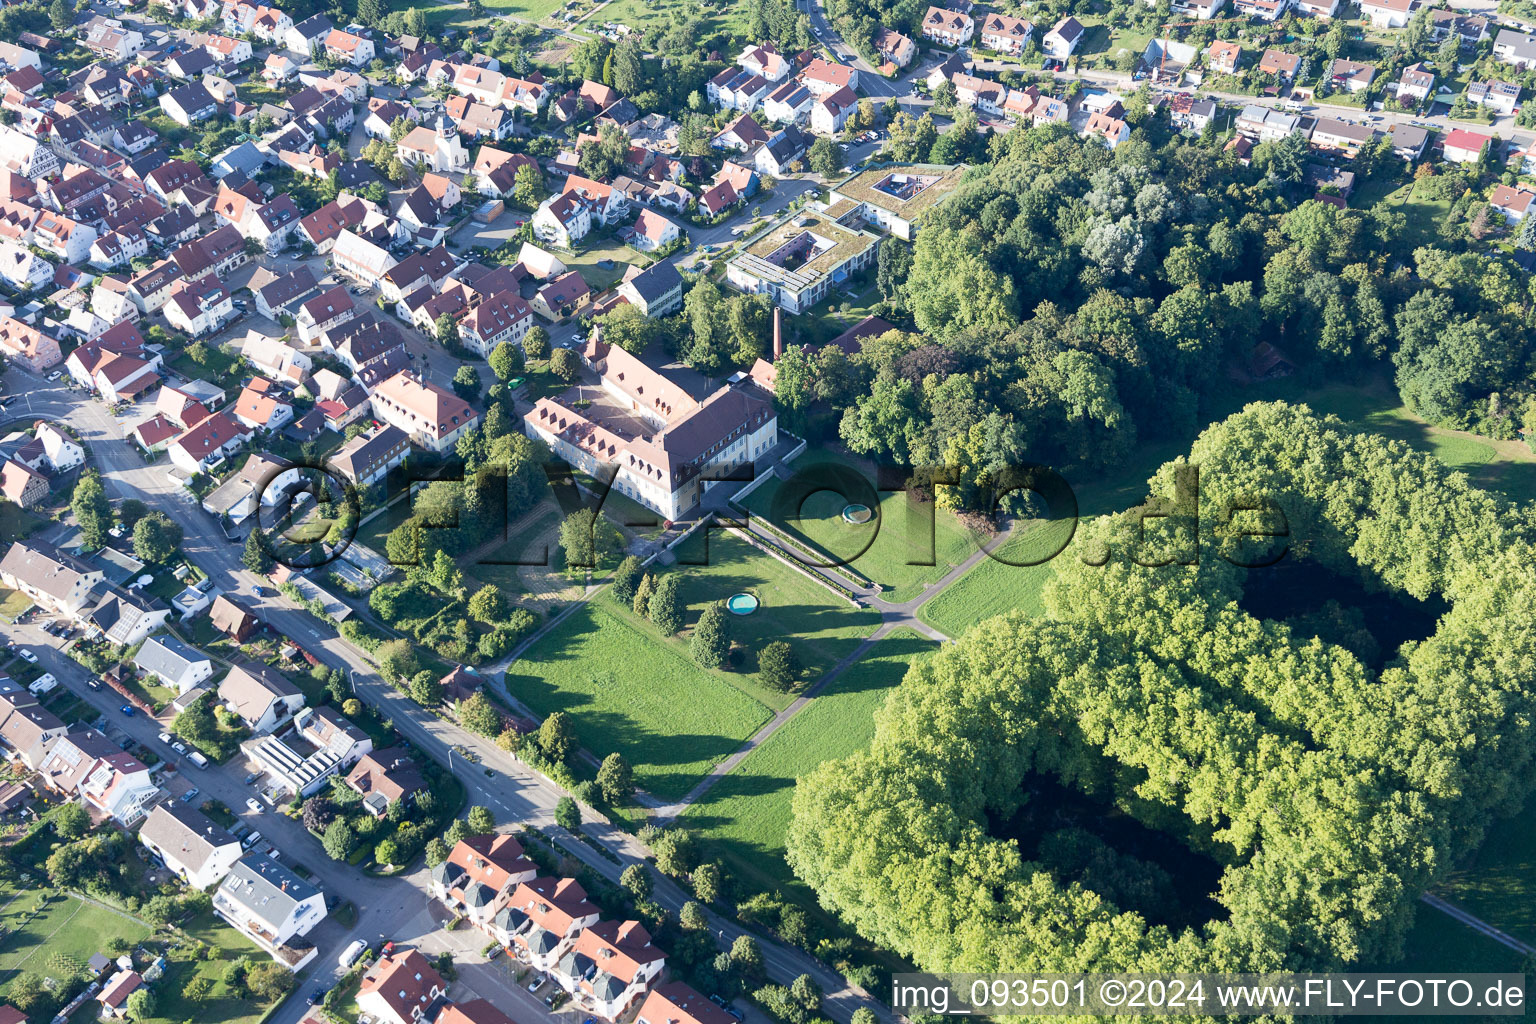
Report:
214,854,326,970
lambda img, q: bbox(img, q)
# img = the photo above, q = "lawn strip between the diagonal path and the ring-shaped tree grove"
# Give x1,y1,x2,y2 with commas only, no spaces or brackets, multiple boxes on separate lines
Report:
684,629,937,889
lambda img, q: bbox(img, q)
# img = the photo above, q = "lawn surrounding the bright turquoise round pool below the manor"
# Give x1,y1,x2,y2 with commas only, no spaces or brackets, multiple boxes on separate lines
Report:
677,530,880,687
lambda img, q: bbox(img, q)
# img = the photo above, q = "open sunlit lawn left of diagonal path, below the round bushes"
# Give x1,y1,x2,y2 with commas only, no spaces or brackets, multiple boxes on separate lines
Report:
507,599,771,798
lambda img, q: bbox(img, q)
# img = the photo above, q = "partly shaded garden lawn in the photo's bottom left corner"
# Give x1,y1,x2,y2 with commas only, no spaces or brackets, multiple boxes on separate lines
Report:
0,884,152,988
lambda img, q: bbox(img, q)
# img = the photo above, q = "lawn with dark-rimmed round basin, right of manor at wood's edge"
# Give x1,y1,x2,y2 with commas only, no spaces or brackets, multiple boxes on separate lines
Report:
745,451,975,603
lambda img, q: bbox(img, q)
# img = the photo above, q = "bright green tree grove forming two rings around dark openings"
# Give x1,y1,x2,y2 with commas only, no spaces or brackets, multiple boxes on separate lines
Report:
786,404,1536,970
